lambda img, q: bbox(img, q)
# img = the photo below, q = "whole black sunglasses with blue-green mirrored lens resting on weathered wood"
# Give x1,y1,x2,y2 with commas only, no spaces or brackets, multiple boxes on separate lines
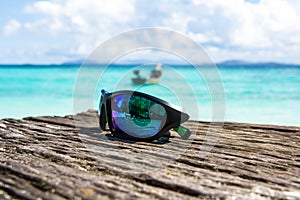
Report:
99,90,191,141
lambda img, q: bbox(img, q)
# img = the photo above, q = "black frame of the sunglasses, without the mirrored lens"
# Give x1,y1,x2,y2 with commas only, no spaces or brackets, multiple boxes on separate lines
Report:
99,90,189,141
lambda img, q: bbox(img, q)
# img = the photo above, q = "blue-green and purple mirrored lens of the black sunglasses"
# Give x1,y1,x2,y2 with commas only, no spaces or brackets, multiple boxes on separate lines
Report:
111,94,167,138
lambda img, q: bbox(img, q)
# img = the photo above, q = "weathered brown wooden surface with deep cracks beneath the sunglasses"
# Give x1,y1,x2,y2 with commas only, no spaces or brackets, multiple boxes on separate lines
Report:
0,111,300,199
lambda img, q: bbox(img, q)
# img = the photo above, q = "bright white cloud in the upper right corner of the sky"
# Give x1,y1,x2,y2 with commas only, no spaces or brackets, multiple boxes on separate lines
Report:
230,0,300,48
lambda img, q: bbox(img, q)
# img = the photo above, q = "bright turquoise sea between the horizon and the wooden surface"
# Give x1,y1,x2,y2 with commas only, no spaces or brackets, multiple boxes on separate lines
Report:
0,64,300,126
